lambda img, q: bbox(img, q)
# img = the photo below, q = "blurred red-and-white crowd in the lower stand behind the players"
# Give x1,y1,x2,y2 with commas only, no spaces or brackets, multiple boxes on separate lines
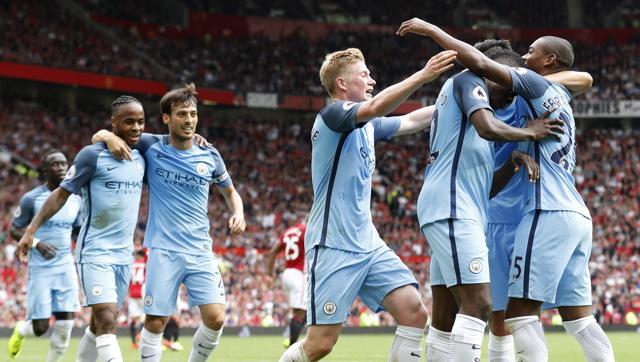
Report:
0,102,640,327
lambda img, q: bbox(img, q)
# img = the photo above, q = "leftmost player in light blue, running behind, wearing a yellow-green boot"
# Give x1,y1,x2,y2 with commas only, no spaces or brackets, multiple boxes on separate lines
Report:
9,150,82,362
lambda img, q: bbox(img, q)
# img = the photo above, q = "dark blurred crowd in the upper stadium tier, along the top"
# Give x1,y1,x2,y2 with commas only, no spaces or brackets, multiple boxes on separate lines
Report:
0,0,640,100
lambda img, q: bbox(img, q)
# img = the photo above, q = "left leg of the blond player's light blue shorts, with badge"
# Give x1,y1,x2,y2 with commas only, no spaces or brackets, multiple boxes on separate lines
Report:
306,246,372,325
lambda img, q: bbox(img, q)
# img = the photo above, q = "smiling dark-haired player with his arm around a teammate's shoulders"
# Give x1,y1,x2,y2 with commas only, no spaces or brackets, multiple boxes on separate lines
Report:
94,84,245,362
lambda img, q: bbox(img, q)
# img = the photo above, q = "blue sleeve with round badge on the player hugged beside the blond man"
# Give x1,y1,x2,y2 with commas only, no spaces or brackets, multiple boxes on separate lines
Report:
452,71,493,118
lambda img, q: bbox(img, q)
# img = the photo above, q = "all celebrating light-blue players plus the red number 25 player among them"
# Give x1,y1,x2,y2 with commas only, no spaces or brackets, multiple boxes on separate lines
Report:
9,18,614,362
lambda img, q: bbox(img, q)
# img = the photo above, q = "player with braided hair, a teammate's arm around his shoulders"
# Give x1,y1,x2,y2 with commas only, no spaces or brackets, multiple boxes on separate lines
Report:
18,96,145,362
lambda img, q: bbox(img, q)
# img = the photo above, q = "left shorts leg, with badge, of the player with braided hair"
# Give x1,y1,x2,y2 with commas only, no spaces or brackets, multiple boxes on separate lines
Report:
77,263,118,307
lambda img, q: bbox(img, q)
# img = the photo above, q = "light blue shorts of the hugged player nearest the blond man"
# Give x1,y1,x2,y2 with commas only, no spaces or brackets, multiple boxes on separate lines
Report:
422,219,489,287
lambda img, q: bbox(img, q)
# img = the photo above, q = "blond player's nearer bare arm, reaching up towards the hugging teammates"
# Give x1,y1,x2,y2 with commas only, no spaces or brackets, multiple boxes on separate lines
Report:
356,51,456,123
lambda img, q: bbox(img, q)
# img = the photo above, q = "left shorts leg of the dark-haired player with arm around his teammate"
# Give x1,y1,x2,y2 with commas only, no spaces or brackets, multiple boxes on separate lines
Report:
144,248,185,317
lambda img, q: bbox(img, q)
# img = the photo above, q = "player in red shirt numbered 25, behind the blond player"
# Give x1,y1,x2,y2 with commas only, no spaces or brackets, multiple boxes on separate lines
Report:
267,222,307,345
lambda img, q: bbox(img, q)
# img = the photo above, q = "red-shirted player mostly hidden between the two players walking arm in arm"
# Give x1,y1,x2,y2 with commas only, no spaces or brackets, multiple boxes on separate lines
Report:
128,249,147,349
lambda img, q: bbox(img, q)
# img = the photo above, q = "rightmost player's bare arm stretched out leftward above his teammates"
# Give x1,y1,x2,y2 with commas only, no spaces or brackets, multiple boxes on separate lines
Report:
396,18,512,89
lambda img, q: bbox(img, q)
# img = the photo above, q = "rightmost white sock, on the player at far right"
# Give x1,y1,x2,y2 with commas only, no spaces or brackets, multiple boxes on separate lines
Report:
562,316,614,362
